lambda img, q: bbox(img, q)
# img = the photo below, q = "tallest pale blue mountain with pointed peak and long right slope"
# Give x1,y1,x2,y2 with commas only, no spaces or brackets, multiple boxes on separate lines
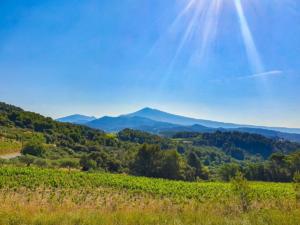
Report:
124,107,300,134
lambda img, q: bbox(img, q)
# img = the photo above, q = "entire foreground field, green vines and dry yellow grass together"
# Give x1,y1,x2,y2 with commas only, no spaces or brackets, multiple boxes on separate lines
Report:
0,167,300,225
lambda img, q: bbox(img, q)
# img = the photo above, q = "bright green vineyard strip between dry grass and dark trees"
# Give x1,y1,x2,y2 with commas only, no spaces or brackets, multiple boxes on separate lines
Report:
0,167,295,200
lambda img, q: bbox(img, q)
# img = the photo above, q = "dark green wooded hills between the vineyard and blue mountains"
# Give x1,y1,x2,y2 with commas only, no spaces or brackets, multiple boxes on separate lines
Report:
0,103,300,182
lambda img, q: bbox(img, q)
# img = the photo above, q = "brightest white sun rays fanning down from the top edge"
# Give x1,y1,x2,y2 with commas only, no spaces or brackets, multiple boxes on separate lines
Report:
171,0,264,73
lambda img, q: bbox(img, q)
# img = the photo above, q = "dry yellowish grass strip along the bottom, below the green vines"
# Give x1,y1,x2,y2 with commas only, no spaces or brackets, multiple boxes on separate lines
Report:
0,188,300,225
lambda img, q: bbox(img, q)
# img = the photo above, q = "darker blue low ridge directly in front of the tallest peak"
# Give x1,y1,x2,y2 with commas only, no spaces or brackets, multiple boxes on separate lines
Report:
85,116,178,133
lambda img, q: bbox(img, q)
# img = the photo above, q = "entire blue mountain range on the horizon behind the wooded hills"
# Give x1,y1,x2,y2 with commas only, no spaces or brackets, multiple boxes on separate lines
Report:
59,107,300,142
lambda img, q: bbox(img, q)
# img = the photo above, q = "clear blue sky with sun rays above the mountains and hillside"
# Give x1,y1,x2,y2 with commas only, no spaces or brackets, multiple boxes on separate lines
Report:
0,0,300,127
